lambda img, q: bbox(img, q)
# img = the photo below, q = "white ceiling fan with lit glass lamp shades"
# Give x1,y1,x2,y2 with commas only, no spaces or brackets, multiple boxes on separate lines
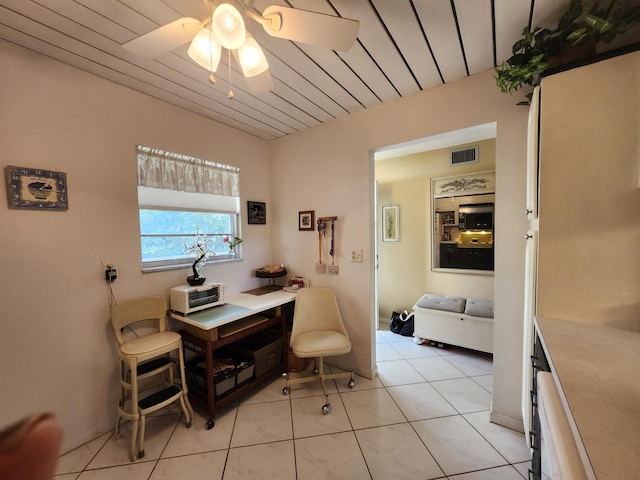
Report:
123,0,360,98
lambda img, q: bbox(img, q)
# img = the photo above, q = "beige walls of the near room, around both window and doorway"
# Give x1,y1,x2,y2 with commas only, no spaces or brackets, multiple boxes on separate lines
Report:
0,37,527,450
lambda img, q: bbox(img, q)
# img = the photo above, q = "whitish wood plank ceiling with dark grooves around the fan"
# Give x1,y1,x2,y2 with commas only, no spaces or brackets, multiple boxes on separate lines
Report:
0,0,592,140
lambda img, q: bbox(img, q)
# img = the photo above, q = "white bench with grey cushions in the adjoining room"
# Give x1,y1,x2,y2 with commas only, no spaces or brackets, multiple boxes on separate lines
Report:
413,294,493,353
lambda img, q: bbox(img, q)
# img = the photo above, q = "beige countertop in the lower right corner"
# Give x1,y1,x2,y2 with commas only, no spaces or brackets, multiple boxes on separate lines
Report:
536,317,640,480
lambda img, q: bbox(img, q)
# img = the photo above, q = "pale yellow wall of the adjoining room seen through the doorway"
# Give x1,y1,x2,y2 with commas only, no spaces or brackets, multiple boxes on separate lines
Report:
374,139,496,319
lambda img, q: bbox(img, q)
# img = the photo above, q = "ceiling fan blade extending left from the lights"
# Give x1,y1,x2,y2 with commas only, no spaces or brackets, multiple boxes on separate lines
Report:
122,17,201,58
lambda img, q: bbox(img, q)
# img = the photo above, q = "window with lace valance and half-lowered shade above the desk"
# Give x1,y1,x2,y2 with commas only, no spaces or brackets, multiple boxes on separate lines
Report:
138,146,242,272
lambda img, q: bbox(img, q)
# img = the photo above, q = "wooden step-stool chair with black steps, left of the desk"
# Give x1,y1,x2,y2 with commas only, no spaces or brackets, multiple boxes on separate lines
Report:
111,297,193,462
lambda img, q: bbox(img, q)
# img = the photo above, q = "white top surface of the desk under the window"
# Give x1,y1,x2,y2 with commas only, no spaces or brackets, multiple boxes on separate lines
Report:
171,290,296,330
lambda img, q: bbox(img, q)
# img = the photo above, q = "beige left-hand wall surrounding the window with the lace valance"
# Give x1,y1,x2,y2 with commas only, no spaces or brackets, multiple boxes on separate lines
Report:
0,42,271,450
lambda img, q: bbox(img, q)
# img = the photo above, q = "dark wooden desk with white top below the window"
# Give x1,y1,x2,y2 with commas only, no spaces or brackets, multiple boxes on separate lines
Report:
171,290,296,429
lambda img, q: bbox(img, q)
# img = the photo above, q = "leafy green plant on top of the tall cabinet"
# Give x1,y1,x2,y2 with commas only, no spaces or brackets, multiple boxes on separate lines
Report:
496,0,640,105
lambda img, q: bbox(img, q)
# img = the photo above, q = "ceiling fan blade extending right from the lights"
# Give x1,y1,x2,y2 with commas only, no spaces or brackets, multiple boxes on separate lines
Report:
262,5,360,52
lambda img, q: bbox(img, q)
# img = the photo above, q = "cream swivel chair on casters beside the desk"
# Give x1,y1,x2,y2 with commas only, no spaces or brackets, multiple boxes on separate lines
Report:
282,287,355,415
